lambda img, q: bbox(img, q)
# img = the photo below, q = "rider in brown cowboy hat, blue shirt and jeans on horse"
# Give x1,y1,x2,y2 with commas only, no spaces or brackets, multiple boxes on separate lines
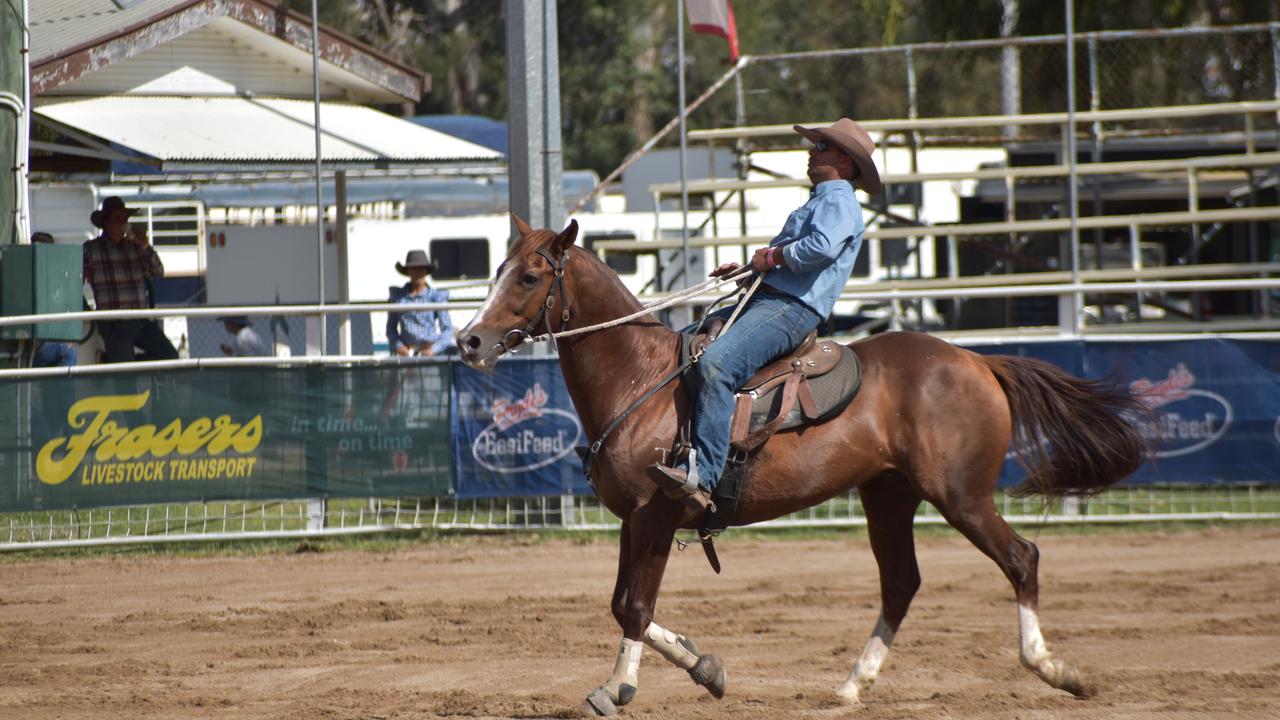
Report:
649,118,881,510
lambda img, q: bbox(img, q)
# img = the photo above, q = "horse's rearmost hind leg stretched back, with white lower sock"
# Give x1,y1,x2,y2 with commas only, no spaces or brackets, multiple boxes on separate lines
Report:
938,492,1093,697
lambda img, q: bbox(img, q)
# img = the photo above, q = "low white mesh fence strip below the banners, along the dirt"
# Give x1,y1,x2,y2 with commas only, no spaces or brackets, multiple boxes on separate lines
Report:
0,483,1280,551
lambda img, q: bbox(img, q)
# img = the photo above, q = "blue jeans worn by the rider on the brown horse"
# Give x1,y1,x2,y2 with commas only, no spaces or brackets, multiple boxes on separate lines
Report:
692,292,822,491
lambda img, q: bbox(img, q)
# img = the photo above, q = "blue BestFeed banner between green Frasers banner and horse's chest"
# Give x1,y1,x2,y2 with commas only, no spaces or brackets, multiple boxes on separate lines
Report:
452,357,591,498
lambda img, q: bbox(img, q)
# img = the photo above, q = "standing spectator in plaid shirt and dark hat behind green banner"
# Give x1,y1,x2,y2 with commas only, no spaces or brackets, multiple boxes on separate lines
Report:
84,196,178,363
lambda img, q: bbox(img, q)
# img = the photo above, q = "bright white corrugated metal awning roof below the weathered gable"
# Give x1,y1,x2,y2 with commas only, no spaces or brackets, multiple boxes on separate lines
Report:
35,96,503,168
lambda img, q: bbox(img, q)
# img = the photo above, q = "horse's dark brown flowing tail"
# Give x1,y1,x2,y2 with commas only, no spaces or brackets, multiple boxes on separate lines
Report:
983,355,1148,497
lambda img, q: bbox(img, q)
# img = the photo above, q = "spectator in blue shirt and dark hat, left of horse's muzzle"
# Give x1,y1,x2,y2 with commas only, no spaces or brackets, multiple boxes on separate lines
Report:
387,250,453,356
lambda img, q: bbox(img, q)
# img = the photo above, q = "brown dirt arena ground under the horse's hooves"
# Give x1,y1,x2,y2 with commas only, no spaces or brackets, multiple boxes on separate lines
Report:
0,527,1280,720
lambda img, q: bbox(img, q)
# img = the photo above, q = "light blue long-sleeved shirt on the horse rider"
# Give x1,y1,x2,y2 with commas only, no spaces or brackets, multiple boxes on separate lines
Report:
764,179,865,318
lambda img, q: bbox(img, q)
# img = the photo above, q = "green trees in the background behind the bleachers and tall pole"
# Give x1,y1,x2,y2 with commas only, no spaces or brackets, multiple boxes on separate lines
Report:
291,0,1280,176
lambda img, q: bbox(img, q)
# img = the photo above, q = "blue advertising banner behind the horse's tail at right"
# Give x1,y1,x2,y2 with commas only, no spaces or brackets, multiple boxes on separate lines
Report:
972,338,1280,484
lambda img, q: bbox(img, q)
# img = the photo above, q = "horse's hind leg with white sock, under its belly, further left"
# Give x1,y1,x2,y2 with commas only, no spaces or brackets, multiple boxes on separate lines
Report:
836,475,920,702
